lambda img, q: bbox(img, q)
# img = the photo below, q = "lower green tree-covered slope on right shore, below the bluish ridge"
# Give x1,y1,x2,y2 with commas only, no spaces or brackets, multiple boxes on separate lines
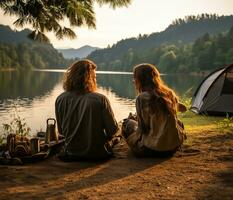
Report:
90,27,233,73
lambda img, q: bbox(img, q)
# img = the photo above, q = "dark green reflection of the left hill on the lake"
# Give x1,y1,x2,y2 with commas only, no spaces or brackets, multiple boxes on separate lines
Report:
0,71,62,101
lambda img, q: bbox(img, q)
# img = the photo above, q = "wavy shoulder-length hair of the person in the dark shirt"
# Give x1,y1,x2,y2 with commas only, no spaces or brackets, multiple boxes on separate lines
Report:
63,59,97,93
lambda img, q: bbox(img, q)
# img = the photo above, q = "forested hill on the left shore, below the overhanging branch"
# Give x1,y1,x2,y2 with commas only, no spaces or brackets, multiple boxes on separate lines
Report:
0,25,68,69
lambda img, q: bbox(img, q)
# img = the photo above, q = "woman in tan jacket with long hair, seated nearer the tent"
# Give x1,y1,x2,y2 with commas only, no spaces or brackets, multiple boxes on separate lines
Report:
122,63,186,157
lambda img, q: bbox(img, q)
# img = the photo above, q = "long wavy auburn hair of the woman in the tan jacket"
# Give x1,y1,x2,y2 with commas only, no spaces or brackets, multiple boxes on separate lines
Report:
134,63,178,115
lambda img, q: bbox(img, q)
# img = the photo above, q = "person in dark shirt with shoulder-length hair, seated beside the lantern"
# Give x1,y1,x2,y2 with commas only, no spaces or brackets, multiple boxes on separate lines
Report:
55,60,118,161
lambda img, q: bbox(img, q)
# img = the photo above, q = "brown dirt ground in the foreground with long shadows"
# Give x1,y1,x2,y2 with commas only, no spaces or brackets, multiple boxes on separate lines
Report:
0,131,233,200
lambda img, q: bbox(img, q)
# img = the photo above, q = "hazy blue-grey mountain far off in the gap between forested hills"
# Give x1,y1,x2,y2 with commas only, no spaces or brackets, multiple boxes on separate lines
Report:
57,45,99,59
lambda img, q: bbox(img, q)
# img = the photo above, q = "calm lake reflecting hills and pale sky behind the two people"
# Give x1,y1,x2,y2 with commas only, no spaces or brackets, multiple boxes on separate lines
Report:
0,70,203,135
